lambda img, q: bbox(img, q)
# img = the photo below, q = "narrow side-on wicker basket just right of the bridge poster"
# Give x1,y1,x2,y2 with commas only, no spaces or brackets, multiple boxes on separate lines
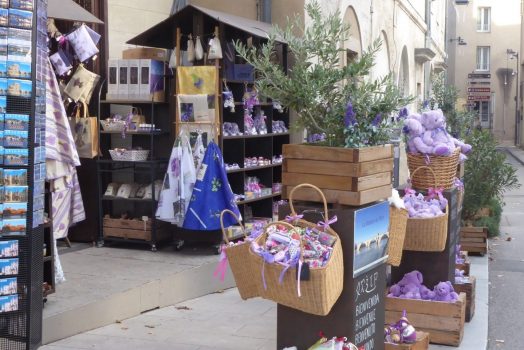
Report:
388,207,408,266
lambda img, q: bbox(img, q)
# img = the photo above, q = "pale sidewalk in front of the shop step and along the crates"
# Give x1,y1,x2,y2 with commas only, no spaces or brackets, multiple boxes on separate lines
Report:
42,256,488,350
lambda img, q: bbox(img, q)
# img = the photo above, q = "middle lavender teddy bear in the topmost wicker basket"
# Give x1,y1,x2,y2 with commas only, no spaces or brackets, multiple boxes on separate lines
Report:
421,109,455,156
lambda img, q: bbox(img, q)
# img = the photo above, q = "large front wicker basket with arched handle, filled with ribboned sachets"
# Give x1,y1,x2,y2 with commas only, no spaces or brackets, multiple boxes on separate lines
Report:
250,184,344,316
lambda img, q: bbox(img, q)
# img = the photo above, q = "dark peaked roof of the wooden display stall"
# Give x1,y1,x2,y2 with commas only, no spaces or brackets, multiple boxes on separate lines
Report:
127,5,284,49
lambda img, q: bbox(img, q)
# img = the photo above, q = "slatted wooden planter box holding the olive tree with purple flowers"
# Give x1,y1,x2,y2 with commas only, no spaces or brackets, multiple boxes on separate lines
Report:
282,144,393,206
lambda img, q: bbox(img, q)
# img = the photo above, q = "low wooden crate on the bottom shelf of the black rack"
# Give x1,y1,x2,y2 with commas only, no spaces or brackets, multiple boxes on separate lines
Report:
104,218,170,242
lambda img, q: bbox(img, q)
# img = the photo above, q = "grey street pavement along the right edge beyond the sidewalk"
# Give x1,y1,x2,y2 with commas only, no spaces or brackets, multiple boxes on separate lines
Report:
488,148,524,350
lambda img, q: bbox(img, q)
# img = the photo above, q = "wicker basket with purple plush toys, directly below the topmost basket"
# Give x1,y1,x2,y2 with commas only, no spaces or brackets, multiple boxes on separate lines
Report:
404,166,449,252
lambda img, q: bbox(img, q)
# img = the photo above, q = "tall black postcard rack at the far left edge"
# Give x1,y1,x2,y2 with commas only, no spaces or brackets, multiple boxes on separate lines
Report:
0,0,47,350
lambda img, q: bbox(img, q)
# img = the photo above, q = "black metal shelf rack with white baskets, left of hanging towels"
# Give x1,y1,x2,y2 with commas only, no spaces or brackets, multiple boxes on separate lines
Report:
97,82,172,251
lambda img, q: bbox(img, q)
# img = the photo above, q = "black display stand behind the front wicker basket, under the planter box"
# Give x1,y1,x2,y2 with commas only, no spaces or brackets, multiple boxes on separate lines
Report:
277,203,386,350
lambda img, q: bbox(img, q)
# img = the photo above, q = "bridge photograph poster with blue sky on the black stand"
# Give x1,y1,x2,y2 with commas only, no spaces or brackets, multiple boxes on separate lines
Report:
353,201,389,278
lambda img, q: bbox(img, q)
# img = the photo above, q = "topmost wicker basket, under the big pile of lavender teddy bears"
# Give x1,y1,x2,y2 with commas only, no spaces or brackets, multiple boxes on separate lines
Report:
408,148,460,189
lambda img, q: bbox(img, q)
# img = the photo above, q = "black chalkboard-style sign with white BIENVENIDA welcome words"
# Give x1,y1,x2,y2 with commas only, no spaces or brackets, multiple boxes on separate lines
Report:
351,266,387,350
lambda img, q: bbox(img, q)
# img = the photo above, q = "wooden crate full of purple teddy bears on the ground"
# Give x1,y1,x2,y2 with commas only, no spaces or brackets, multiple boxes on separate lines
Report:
386,293,466,346
